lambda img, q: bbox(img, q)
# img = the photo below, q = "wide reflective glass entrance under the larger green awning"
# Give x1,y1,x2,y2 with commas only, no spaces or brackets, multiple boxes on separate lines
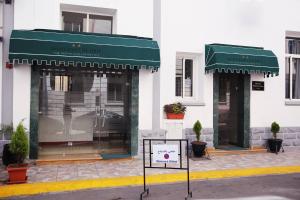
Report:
38,71,130,159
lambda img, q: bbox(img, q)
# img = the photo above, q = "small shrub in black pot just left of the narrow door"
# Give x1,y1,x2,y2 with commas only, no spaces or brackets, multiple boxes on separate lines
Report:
192,120,207,157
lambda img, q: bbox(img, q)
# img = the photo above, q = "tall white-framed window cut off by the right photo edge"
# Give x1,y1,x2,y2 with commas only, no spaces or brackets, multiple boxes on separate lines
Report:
285,34,300,100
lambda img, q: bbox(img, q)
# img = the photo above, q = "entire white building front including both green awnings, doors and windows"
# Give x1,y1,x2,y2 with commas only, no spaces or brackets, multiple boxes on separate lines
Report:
1,0,300,159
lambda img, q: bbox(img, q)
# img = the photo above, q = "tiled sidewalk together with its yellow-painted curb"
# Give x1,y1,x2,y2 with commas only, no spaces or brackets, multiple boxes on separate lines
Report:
0,150,300,197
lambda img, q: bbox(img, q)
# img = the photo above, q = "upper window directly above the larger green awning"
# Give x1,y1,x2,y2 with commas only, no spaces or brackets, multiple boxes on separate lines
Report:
62,11,113,34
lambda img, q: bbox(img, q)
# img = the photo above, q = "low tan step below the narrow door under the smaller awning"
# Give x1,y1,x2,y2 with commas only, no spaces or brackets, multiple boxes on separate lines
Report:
208,147,267,156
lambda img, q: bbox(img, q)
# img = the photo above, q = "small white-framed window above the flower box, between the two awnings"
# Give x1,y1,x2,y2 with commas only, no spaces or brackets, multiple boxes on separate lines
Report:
175,56,194,97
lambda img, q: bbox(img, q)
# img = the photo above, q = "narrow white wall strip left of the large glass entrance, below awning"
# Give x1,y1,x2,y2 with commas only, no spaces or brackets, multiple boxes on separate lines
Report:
13,65,31,130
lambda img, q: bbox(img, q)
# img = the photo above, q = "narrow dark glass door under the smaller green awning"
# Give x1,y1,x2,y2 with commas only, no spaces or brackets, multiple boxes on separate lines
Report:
218,73,244,149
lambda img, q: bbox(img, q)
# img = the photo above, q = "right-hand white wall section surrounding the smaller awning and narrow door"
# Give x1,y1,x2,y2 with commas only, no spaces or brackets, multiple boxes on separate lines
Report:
154,0,300,150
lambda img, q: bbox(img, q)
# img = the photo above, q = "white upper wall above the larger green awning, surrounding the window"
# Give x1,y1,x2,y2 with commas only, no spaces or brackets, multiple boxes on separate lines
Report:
15,0,153,37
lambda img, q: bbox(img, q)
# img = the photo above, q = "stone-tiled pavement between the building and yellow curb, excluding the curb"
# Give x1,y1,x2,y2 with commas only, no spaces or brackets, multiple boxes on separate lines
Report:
0,150,300,184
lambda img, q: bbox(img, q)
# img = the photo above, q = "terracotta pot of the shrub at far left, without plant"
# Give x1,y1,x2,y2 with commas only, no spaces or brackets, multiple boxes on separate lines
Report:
6,164,28,184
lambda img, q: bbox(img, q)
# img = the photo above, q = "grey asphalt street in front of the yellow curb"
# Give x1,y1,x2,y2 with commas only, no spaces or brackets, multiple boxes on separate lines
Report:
9,174,300,200
